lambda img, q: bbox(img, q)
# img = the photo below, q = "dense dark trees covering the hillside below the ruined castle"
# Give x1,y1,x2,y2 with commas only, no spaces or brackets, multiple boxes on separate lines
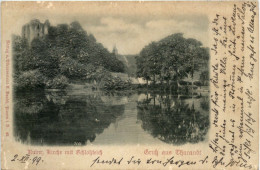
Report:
13,22,124,88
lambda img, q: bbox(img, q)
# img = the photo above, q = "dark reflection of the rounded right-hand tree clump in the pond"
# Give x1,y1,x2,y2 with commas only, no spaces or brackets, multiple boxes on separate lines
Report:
137,93,209,144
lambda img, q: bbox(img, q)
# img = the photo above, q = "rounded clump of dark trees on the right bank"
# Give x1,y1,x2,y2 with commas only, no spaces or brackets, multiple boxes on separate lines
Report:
136,33,209,91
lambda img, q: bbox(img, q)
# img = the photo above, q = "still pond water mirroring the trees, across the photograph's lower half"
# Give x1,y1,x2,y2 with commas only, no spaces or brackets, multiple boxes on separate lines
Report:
14,89,209,145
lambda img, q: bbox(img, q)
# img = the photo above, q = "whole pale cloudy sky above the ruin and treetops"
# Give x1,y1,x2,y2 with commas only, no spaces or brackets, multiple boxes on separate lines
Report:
14,13,209,55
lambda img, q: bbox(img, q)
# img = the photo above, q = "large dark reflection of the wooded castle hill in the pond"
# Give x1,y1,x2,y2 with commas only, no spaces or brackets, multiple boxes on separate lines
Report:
14,92,124,145
